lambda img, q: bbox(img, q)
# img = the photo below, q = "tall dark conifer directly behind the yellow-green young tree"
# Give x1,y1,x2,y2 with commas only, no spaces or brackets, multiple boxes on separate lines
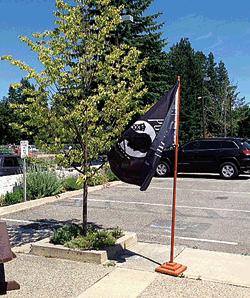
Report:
92,0,170,106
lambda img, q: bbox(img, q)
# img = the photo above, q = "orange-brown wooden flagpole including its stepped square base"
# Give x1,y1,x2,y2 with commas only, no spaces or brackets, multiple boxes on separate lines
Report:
155,77,187,276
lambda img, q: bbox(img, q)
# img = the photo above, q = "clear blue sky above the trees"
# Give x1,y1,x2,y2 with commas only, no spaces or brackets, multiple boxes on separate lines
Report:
0,0,250,103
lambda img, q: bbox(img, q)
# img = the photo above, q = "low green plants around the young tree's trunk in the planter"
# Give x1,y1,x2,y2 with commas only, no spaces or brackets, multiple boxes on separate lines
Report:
50,224,123,250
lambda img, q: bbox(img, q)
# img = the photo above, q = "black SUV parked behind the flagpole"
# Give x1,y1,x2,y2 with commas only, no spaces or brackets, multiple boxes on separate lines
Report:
156,138,250,179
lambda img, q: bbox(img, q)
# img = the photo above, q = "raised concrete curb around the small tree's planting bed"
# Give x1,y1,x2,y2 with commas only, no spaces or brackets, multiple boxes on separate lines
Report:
29,232,137,264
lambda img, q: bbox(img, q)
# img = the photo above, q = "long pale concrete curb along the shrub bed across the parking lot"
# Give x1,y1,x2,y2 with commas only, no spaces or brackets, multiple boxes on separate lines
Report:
0,181,123,216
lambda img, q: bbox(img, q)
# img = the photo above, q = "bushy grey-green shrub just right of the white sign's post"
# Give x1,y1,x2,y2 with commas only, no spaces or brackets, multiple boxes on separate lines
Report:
21,167,63,200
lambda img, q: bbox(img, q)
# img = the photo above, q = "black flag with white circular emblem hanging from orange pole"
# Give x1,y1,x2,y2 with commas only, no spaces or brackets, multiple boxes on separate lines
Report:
108,82,179,191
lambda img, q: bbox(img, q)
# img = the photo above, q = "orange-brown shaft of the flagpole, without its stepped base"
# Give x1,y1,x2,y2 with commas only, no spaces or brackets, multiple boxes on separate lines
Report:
170,77,180,263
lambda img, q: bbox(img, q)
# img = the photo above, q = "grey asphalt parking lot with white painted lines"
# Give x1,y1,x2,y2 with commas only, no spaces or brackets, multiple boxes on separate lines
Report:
2,174,250,255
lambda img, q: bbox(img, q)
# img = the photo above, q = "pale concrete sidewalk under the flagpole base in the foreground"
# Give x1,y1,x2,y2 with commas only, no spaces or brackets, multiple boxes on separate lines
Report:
5,242,250,298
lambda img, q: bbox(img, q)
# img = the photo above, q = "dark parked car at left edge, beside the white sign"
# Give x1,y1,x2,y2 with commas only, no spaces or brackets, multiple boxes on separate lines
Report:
0,154,22,176
